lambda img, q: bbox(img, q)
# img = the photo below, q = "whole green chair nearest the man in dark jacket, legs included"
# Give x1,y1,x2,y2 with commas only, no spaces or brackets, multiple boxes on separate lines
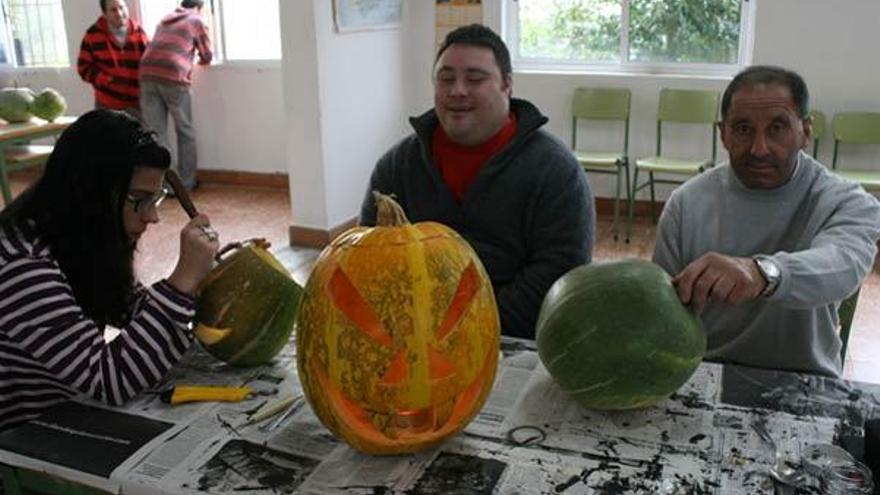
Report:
571,88,631,241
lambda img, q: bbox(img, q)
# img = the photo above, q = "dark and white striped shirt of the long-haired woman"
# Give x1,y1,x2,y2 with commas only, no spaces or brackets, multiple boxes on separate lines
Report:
0,223,195,431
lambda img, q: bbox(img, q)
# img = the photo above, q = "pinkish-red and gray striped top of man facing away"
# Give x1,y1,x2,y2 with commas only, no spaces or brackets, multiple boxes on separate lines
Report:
141,7,214,86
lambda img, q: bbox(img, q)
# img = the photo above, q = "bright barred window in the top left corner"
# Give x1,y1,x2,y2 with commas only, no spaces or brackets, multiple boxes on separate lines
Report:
0,0,70,67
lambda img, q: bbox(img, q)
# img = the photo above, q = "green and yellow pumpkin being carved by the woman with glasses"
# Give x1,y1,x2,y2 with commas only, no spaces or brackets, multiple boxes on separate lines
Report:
194,245,302,366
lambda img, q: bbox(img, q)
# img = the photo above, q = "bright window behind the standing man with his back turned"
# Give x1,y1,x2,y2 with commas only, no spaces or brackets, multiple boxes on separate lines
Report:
141,0,281,60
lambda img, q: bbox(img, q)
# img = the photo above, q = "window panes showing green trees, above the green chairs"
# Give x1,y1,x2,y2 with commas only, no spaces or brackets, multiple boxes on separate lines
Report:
505,0,749,72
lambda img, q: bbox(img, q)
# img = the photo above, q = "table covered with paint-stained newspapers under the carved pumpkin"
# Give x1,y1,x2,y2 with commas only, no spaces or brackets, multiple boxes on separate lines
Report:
0,338,880,495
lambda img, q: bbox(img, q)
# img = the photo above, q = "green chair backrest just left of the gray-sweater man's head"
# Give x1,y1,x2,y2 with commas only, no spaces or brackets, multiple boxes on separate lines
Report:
657,88,721,164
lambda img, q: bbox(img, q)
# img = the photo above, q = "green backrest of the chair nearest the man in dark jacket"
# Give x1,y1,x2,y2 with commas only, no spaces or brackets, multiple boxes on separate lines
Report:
571,88,630,155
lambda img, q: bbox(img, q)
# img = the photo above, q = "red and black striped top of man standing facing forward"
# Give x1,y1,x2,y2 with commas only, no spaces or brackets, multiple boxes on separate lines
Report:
76,17,149,110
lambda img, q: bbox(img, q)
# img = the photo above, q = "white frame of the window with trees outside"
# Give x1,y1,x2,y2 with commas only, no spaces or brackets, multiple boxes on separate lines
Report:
501,0,756,78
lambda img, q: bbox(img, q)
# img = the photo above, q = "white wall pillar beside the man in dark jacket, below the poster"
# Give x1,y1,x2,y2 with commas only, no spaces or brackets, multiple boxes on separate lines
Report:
281,0,408,230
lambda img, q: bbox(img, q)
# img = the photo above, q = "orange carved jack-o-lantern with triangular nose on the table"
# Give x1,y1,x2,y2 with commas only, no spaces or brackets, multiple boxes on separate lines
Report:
296,195,500,454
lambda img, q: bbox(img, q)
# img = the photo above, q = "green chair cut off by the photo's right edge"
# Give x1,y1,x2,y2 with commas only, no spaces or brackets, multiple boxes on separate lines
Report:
831,112,880,191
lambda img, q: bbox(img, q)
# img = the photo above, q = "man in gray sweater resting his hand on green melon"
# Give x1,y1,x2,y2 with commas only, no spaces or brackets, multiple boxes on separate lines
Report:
654,66,880,376
